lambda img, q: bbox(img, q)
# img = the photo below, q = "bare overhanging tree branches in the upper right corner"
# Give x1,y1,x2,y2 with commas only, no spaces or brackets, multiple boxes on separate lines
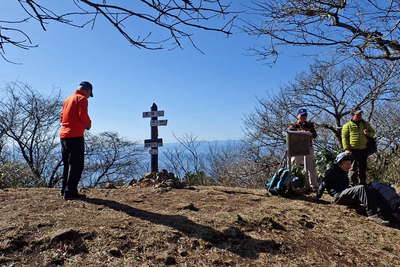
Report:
245,0,400,61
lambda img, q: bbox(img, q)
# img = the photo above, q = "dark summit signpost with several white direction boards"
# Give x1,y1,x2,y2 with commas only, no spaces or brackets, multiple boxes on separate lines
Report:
143,103,168,172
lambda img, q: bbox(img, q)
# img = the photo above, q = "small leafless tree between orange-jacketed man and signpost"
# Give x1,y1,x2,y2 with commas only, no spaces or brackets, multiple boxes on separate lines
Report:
81,132,145,187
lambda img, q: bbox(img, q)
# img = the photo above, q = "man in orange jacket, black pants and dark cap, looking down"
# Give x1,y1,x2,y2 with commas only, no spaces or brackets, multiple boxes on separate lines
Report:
60,82,93,200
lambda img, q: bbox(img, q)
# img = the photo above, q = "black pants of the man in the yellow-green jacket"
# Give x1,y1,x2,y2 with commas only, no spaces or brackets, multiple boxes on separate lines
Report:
349,149,368,185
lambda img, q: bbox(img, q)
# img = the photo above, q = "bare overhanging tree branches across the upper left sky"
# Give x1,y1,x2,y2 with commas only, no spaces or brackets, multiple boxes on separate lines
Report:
0,0,235,62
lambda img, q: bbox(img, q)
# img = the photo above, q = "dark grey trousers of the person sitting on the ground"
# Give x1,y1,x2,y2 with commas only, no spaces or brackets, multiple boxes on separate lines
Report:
335,185,378,216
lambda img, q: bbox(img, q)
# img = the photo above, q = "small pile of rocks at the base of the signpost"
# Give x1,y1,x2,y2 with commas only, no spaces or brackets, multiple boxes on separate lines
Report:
129,169,185,191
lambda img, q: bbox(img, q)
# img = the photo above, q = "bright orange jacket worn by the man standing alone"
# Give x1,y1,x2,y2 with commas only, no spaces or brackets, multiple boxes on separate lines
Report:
60,90,92,138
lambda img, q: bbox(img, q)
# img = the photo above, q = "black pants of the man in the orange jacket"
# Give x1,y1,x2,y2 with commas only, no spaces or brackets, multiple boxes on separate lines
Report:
60,137,85,193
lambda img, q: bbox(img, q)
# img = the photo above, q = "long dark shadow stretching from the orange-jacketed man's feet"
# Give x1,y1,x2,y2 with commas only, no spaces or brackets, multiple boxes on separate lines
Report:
83,198,286,259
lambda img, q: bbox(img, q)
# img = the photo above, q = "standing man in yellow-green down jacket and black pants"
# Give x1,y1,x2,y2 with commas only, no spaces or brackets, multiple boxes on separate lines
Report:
342,107,375,185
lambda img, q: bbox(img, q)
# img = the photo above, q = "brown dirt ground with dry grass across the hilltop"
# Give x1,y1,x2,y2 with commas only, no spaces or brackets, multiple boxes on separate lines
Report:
0,186,400,267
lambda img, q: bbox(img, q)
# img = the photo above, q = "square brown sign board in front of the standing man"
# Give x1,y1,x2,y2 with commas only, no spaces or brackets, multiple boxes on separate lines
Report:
287,131,312,157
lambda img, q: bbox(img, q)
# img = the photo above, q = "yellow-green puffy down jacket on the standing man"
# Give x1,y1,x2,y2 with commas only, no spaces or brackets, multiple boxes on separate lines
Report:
342,120,375,150
